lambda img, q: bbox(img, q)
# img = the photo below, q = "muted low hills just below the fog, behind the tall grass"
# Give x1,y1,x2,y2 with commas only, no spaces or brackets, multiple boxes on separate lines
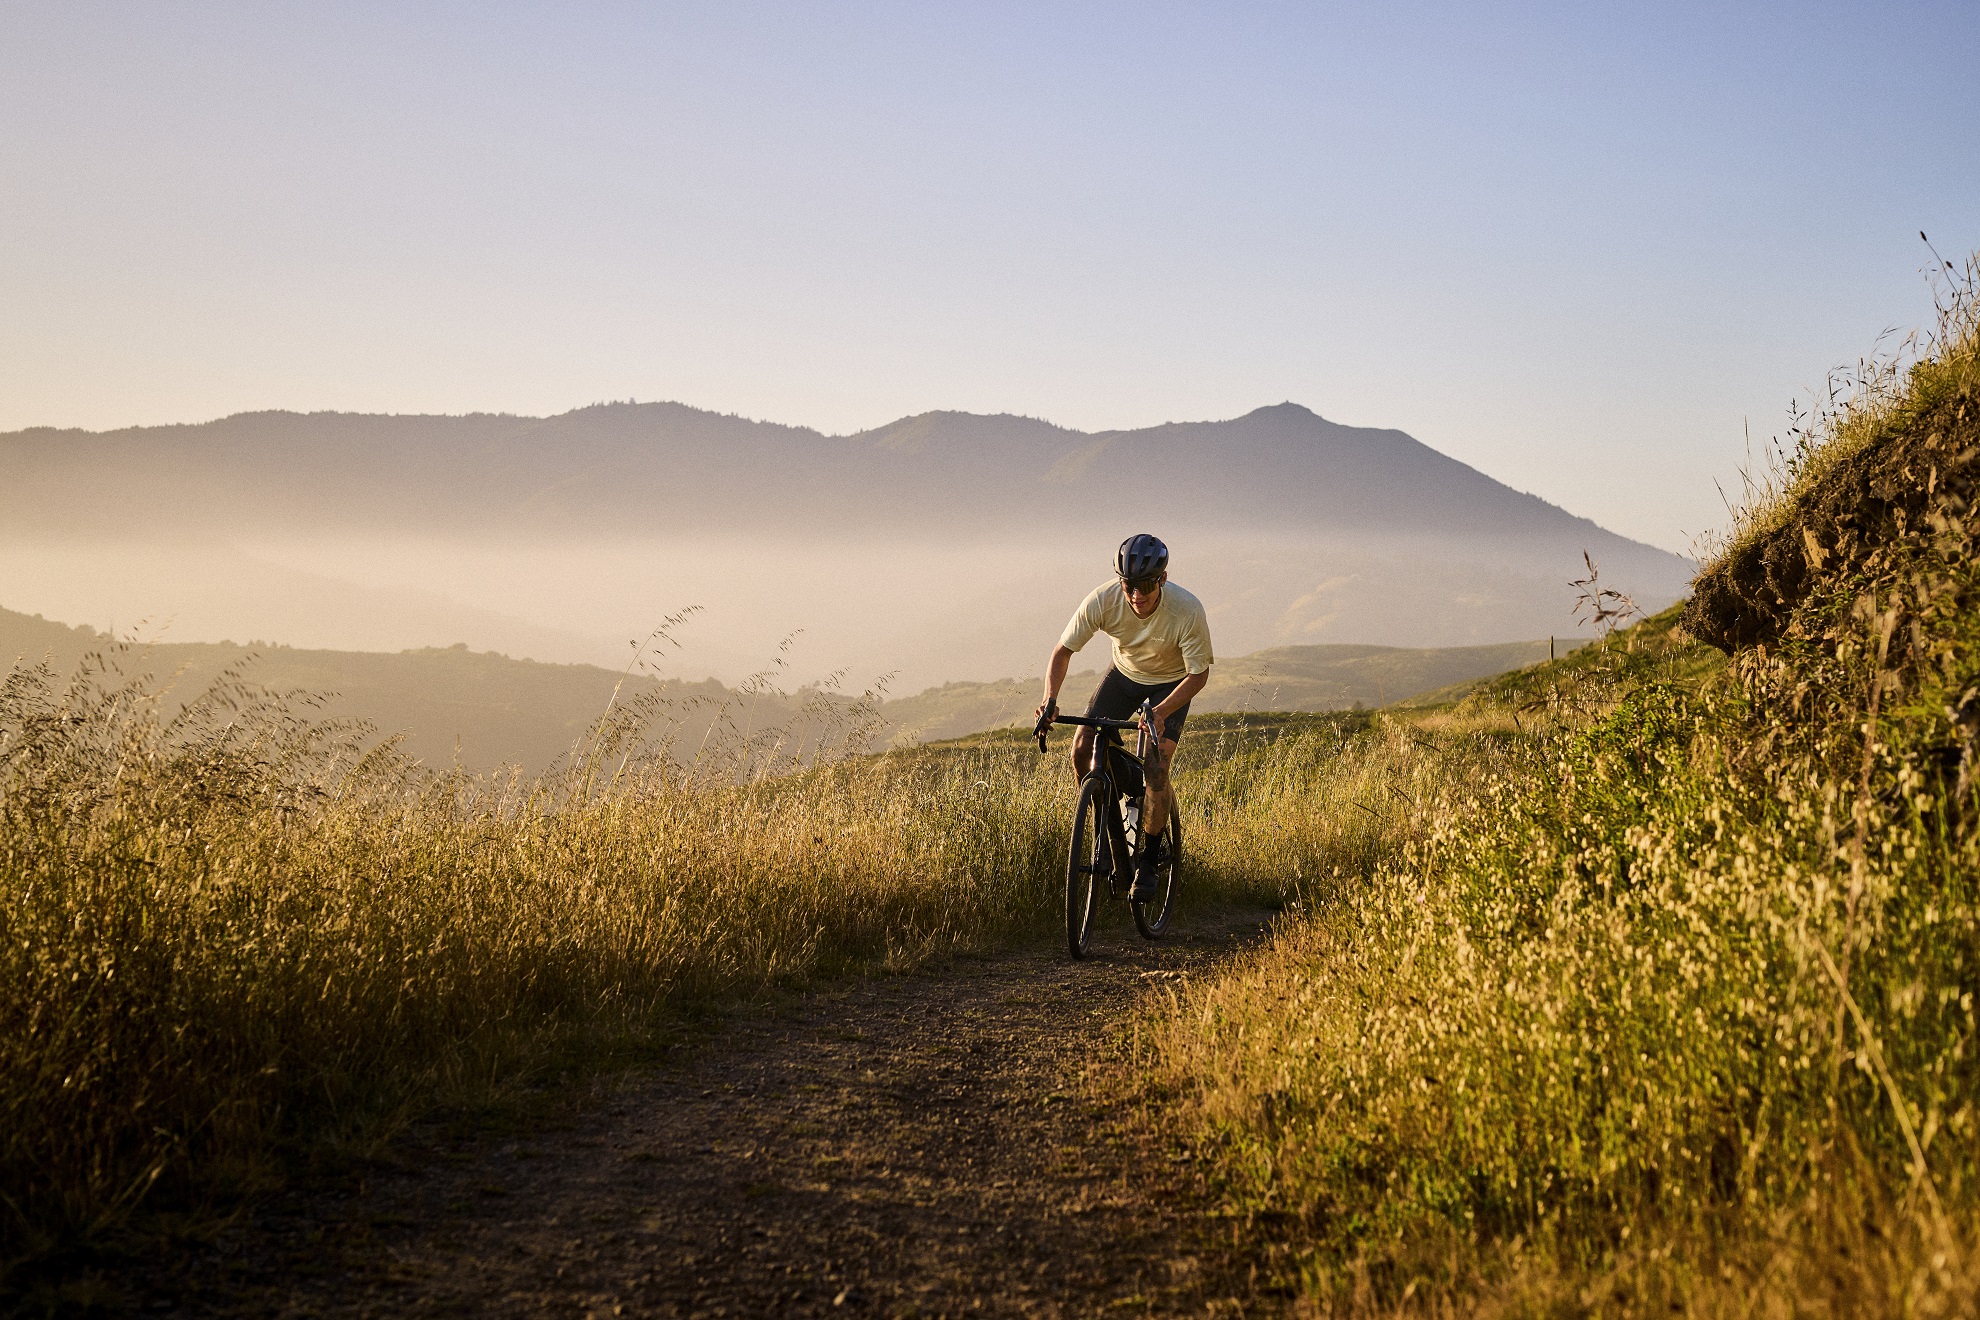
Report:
0,608,1560,776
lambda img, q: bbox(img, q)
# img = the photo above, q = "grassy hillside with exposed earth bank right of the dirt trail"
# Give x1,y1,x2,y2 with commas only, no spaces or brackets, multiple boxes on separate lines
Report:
1139,263,1980,1316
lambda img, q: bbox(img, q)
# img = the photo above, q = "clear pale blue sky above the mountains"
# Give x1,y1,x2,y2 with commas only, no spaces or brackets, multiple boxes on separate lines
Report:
0,0,1980,550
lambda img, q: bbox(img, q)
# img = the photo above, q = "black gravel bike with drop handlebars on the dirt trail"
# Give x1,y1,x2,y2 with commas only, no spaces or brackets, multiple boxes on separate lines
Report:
1032,701,1182,958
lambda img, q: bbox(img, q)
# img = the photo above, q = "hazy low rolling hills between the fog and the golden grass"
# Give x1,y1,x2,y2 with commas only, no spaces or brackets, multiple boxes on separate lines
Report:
0,610,1580,772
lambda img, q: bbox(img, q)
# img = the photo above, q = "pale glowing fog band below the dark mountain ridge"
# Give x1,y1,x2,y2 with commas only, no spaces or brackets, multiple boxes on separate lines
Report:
0,536,1665,693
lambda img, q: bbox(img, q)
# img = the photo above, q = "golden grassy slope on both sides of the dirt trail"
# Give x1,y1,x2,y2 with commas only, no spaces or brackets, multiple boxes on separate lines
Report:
11,271,1980,1316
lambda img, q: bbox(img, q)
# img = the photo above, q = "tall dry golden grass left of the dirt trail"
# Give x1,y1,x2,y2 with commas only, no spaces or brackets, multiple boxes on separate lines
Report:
0,653,1290,1267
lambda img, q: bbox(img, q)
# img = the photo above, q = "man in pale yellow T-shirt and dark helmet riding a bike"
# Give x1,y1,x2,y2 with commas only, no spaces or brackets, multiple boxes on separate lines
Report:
1038,532,1212,902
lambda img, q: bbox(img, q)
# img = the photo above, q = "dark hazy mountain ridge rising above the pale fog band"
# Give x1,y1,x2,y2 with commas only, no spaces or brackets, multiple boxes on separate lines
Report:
0,404,1677,560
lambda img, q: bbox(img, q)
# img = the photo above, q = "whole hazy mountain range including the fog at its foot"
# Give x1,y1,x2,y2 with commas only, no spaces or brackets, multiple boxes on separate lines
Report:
0,404,1693,695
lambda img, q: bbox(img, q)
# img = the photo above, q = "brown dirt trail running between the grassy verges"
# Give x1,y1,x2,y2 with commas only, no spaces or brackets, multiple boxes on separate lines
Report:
162,912,1277,1318
